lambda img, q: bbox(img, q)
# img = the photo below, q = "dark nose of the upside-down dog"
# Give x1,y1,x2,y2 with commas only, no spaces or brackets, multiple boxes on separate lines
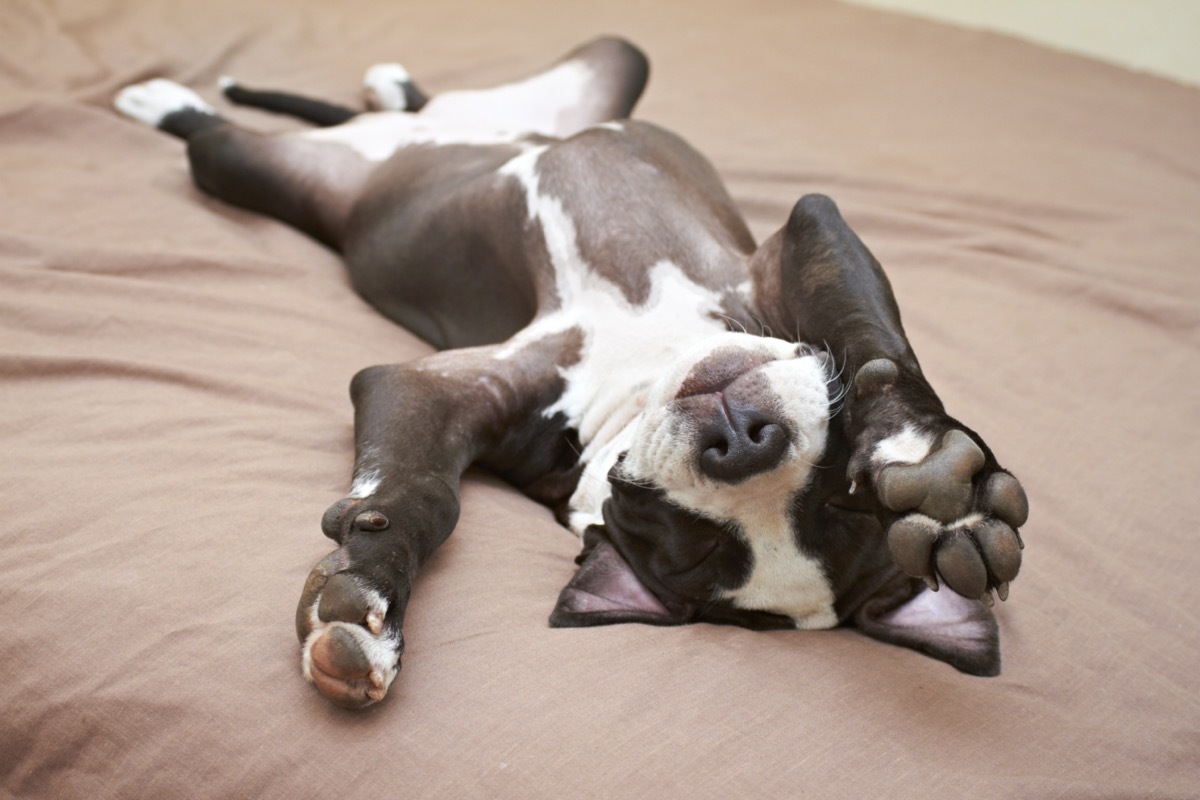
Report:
700,404,787,483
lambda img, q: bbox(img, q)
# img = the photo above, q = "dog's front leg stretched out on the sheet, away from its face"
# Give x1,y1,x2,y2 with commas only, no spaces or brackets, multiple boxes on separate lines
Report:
296,333,578,708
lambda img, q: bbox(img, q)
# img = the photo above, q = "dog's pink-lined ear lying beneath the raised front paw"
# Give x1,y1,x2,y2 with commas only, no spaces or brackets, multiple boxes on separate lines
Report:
854,587,1000,676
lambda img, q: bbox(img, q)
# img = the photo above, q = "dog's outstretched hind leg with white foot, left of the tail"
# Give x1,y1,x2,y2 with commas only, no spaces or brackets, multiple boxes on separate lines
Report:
115,79,373,248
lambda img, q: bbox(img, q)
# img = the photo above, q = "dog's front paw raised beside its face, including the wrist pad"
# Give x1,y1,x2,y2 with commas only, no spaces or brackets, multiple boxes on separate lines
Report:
851,359,1028,604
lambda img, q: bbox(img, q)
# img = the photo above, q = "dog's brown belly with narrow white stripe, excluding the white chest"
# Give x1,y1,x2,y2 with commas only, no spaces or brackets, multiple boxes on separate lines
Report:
344,122,754,348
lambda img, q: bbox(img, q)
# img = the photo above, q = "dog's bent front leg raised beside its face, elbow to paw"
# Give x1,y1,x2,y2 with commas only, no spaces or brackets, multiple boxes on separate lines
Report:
751,196,1028,604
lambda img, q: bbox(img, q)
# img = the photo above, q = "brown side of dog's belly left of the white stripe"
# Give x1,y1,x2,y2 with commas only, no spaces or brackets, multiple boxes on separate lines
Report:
344,144,539,349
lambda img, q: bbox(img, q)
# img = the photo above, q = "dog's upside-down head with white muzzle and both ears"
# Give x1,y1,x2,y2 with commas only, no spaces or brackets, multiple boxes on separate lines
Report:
551,333,998,674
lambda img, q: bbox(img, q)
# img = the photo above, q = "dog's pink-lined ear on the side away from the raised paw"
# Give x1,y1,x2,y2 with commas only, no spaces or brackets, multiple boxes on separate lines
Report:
550,525,685,627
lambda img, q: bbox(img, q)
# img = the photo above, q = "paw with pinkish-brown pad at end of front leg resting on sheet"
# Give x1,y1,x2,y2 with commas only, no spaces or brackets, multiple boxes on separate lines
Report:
296,548,404,709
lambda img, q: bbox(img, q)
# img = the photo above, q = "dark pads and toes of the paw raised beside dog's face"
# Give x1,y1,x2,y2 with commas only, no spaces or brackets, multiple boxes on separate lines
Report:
875,428,1028,604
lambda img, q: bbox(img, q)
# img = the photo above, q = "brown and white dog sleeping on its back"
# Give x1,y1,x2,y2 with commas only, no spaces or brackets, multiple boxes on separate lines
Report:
115,37,1028,708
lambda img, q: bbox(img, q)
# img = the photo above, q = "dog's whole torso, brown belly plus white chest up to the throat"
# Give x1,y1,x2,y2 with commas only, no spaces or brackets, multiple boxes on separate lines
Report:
347,117,782,533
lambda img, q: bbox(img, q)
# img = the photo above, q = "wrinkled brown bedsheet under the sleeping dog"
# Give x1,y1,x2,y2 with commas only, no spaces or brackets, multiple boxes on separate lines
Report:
0,0,1200,798
